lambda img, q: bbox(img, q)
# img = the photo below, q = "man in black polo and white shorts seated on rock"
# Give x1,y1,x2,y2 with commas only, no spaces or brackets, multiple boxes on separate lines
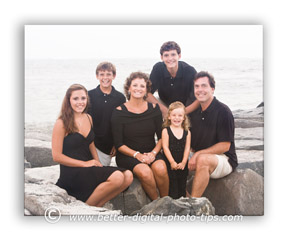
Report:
188,72,238,197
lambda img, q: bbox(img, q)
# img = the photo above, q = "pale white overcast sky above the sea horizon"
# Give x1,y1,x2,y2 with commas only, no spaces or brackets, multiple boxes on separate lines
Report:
25,25,263,59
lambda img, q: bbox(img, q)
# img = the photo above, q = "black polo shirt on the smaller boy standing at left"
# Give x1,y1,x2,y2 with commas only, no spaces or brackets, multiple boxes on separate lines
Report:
88,85,126,154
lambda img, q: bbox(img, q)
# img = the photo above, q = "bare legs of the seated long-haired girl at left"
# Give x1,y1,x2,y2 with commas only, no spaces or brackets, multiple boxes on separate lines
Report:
86,171,133,207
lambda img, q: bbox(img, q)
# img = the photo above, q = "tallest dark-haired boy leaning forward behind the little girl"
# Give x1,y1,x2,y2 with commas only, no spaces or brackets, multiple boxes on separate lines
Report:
147,41,199,116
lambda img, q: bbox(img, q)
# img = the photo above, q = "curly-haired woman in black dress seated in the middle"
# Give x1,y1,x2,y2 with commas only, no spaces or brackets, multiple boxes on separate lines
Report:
112,72,169,200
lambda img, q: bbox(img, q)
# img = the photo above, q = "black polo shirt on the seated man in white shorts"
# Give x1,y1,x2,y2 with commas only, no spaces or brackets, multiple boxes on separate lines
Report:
191,97,238,169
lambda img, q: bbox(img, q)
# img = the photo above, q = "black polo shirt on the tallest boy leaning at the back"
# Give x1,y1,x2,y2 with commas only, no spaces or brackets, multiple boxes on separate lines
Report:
150,61,196,106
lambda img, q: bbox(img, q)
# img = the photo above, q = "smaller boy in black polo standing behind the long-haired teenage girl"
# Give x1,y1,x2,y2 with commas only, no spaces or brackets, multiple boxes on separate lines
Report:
88,62,126,166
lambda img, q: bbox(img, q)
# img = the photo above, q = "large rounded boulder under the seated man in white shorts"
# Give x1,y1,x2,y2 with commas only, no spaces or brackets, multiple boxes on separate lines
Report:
187,169,264,216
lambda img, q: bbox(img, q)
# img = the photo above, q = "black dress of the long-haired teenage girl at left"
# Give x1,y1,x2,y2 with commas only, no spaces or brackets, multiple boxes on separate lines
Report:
56,117,123,202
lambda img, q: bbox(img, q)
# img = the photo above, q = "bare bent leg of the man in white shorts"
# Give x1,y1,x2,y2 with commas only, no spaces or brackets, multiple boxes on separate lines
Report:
191,154,218,197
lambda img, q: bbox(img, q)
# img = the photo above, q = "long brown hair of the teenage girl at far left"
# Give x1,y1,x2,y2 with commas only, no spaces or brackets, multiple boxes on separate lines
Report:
58,84,89,134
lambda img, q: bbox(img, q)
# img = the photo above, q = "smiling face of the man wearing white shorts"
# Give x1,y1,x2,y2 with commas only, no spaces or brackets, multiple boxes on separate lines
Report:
194,77,215,109
